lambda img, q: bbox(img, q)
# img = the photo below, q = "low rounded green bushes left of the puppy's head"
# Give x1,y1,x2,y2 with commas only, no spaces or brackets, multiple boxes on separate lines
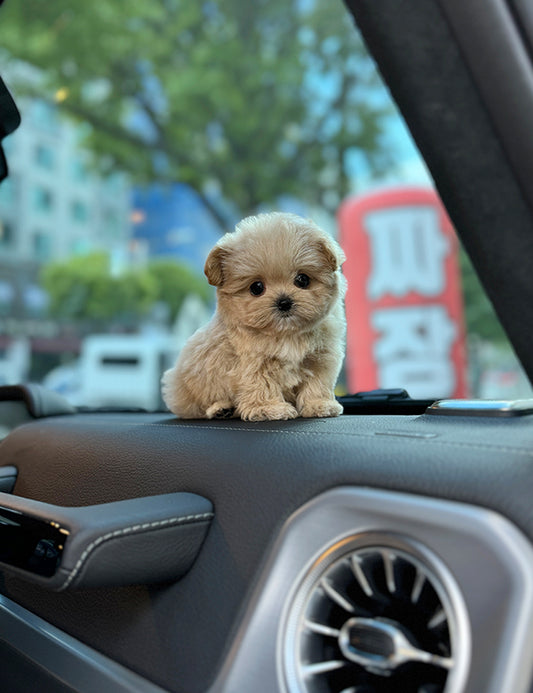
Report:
41,253,209,323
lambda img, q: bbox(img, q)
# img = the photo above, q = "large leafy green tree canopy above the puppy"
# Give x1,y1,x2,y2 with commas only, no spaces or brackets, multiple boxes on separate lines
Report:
2,0,391,225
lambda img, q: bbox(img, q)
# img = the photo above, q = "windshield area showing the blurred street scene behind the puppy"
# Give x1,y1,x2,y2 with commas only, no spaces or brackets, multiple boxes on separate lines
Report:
0,0,530,409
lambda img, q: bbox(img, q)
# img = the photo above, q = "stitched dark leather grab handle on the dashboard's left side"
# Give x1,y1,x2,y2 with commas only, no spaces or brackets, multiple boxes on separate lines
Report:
0,492,213,591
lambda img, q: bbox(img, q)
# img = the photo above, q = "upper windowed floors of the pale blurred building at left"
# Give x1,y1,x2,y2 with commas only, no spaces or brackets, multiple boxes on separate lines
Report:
0,100,131,265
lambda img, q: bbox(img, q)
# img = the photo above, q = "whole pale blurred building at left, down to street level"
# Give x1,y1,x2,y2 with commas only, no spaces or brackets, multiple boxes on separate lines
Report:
0,93,131,380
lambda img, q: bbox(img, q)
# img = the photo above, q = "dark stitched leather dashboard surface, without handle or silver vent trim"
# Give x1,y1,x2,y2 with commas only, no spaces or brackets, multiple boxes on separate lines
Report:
0,414,533,693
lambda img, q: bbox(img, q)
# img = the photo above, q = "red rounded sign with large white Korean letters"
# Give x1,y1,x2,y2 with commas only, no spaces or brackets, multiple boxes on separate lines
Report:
339,188,467,399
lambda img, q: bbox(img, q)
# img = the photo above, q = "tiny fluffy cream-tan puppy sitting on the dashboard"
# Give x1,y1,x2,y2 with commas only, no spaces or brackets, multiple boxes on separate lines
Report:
162,212,345,421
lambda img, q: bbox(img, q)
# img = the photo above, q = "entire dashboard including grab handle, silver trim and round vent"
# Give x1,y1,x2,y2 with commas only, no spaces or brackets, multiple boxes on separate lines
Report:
0,400,533,693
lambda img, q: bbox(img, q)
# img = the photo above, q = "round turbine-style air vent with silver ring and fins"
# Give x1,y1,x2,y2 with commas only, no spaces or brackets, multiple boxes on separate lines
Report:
281,538,457,693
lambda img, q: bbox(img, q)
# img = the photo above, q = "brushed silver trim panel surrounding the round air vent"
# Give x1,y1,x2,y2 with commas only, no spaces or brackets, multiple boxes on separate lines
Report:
209,487,533,693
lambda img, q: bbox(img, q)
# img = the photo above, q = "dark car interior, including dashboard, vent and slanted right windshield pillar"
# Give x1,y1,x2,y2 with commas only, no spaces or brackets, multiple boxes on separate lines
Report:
0,0,533,693
